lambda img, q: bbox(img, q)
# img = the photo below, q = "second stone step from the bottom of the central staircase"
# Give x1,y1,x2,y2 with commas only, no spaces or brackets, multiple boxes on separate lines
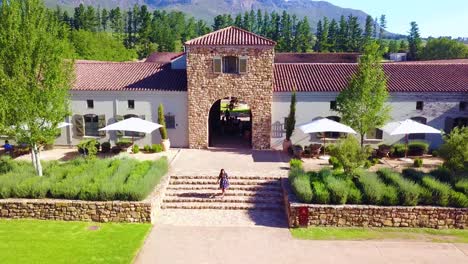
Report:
163,196,282,205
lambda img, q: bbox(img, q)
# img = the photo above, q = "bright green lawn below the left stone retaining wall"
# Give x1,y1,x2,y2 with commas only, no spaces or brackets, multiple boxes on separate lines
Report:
0,220,151,264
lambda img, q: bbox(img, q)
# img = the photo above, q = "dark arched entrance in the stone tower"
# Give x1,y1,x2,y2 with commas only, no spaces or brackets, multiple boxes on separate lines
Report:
208,97,252,148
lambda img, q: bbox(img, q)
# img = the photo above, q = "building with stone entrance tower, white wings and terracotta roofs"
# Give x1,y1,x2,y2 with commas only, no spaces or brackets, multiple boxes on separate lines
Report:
56,27,468,149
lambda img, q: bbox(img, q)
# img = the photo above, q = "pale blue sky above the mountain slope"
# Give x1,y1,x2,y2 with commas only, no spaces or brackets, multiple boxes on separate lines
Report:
327,0,468,37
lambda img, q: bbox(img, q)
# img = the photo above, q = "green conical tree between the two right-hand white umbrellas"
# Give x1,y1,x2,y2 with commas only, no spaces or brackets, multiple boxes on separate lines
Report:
336,41,390,147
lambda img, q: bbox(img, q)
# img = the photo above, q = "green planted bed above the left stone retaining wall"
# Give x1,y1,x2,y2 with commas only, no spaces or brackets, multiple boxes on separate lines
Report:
0,158,168,201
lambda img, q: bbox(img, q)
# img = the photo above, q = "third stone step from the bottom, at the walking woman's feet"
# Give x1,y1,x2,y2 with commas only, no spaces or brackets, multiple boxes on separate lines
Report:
166,189,282,198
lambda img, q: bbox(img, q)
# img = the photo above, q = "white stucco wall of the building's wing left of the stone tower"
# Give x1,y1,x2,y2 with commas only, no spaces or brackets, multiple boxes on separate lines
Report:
55,91,188,147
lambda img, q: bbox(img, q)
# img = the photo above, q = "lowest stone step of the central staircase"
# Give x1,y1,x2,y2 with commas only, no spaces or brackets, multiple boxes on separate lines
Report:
161,203,283,211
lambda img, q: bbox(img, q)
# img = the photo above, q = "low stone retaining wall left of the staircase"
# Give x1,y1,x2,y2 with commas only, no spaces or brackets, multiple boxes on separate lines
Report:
0,199,151,223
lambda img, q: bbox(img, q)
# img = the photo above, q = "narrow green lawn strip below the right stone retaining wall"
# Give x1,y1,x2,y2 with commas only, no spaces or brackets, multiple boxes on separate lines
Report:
290,227,468,243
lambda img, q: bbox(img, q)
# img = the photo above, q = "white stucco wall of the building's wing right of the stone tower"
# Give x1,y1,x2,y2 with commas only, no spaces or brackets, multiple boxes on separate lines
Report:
271,92,468,149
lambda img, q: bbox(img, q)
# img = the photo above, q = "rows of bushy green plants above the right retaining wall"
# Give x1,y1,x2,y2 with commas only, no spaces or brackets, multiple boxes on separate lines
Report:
289,167,468,208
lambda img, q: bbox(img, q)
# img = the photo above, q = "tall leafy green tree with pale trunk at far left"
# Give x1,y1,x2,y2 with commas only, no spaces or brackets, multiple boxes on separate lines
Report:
0,0,73,176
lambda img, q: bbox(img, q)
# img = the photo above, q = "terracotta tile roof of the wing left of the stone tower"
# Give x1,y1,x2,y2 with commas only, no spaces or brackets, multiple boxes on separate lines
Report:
72,62,187,91
